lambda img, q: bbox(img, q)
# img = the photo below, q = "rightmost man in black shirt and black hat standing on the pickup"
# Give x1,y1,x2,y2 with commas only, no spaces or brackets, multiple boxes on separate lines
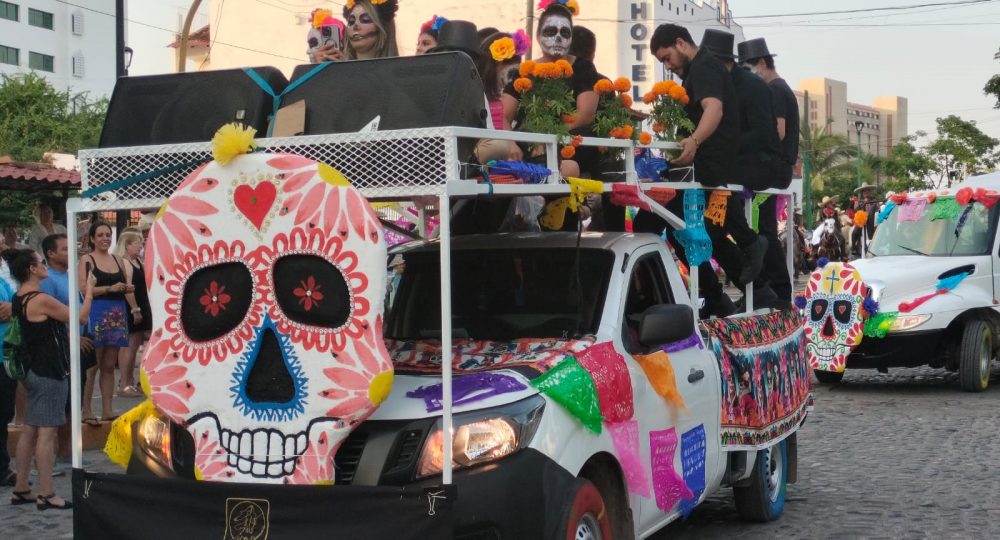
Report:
737,38,799,298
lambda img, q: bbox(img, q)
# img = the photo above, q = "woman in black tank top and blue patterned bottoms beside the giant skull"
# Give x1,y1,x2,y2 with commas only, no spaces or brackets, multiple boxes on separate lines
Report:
78,221,137,425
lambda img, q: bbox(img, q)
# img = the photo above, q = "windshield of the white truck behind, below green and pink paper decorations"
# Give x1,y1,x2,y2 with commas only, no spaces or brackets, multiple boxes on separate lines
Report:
868,203,1000,257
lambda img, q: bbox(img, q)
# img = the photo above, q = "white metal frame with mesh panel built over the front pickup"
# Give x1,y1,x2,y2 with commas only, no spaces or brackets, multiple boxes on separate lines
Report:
66,127,793,484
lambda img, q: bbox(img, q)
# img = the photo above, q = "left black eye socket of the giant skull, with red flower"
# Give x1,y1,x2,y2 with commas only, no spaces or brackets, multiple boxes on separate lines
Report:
181,263,253,343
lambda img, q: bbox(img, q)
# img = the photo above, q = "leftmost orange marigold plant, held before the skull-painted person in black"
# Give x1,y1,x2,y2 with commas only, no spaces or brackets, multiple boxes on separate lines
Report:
514,60,579,159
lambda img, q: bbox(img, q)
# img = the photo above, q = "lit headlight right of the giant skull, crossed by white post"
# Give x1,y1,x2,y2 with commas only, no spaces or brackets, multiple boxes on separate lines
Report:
417,396,545,477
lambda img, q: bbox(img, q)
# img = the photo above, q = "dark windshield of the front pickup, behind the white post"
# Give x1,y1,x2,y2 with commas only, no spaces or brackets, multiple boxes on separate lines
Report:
384,248,614,341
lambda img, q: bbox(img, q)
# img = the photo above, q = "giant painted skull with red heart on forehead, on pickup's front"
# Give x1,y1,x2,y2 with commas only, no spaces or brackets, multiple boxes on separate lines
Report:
142,154,393,484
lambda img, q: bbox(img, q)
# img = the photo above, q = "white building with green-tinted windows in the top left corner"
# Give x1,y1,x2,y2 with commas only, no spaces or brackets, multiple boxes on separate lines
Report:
0,0,116,98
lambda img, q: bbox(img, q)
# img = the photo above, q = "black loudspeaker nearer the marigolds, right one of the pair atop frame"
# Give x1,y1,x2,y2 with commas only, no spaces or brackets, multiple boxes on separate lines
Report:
282,52,486,135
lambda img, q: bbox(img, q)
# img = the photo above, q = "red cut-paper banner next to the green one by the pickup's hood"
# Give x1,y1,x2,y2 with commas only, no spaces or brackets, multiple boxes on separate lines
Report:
576,341,634,424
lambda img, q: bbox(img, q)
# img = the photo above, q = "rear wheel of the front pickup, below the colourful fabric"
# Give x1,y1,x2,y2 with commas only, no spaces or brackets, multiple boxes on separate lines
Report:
733,441,788,523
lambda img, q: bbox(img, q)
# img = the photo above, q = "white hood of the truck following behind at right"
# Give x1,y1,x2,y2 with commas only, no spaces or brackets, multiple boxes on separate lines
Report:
851,255,993,312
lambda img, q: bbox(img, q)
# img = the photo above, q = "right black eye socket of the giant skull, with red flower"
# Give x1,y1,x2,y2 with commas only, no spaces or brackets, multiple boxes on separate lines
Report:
274,255,351,328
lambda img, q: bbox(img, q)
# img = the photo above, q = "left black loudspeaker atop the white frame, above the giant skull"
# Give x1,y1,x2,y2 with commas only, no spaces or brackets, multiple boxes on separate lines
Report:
100,67,288,148
